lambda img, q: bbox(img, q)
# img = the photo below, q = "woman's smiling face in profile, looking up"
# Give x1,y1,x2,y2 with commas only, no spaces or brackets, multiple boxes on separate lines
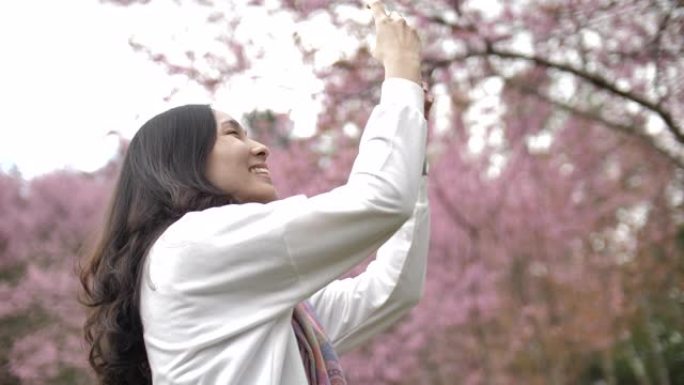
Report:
206,111,278,203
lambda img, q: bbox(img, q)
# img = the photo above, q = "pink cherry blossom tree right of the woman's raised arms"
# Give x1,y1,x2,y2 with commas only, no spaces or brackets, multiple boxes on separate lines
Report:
104,0,684,384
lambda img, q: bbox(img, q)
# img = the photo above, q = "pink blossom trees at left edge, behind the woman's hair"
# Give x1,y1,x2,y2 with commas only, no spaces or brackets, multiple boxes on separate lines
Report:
0,169,111,384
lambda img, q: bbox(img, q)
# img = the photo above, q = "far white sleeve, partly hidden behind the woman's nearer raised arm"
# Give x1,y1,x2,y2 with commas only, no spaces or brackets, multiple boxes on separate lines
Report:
310,177,430,354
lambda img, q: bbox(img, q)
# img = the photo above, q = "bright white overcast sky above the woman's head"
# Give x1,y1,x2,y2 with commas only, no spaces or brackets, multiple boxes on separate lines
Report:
0,0,342,178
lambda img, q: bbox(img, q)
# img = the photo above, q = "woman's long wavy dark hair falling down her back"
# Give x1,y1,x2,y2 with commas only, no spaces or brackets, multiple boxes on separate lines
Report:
80,105,234,385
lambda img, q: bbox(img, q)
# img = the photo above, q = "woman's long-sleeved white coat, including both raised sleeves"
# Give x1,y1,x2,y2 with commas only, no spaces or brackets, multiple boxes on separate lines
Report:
140,78,429,385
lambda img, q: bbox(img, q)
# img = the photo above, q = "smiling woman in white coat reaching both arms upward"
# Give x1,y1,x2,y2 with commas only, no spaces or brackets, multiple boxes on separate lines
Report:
81,1,429,385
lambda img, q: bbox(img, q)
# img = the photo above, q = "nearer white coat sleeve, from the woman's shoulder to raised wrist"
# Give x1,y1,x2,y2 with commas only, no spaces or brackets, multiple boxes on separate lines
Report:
149,78,427,324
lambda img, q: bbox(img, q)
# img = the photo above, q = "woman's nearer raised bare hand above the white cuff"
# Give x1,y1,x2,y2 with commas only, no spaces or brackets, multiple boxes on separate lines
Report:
366,0,421,84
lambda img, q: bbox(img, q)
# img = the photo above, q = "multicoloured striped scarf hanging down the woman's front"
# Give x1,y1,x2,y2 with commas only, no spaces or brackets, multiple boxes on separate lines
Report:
292,301,347,385
